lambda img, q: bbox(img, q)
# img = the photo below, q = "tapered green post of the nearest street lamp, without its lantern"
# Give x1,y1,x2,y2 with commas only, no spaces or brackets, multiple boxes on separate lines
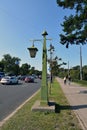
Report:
41,31,48,105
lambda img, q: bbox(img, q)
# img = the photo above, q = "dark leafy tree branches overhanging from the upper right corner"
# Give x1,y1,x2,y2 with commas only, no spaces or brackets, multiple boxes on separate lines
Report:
57,0,87,48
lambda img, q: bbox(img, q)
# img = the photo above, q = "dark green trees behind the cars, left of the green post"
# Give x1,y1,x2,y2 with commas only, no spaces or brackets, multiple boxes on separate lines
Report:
0,54,41,76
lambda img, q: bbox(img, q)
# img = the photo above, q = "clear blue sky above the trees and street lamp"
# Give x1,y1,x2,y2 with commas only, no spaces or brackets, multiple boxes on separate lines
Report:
0,0,87,70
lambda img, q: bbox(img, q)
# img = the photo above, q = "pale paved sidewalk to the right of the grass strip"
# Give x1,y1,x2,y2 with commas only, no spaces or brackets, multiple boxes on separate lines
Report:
56,77,87,130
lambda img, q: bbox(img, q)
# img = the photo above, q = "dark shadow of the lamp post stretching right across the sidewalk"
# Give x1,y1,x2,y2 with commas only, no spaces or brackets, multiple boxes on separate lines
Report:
55,104,87,113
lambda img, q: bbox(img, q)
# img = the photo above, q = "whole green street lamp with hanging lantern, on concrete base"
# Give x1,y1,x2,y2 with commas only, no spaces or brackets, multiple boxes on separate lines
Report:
28,31,51,106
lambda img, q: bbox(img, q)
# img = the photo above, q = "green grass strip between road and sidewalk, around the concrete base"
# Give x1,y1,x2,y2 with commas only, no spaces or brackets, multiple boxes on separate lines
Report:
0,80,82,130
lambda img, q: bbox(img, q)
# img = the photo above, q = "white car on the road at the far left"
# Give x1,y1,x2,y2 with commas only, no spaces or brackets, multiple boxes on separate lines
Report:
0,76,18,84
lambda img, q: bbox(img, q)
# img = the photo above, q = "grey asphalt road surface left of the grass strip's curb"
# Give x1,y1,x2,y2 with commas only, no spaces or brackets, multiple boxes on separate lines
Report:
0,79,41,121
